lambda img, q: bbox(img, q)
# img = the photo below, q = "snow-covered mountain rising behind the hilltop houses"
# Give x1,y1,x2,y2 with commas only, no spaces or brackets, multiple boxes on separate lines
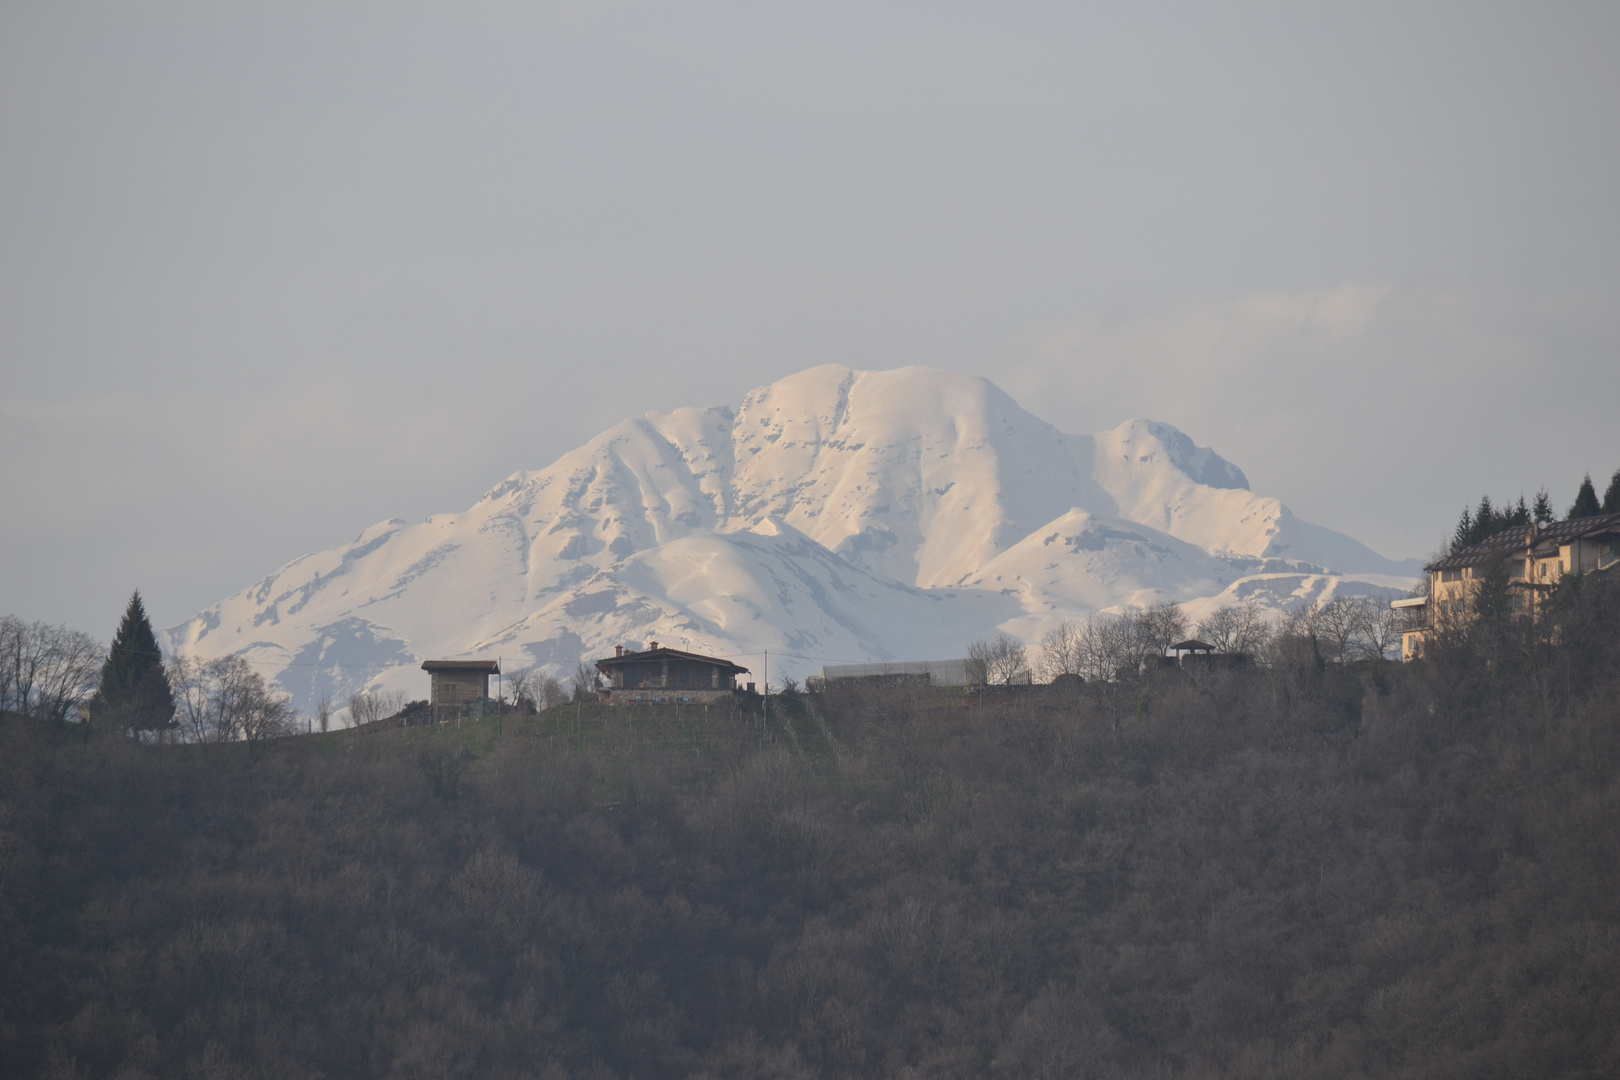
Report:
167,366,1418,712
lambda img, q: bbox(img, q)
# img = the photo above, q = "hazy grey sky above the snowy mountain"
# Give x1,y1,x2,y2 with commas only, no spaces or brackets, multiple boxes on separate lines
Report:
0,0,1620,638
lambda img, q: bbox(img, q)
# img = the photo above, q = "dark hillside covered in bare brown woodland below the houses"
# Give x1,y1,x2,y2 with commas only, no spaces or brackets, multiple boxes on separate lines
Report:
0,580,1620,1080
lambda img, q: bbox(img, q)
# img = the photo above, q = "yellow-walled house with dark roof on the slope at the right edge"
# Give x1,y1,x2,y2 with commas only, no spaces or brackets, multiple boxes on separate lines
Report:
1390,513,1620,661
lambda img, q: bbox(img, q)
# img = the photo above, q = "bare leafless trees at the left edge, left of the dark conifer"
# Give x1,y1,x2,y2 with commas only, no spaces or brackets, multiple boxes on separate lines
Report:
0,615,105,722
